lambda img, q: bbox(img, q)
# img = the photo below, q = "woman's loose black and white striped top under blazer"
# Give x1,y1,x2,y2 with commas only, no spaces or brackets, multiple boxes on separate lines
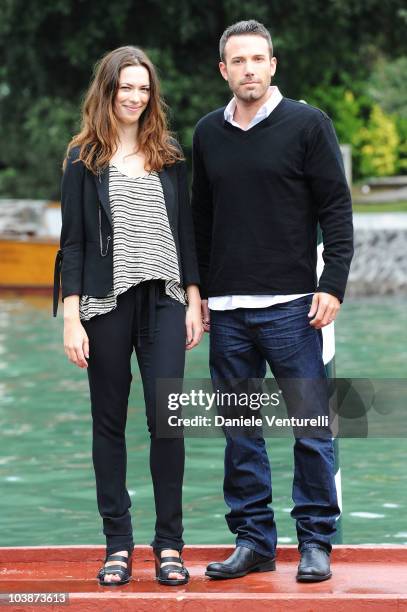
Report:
79,164,186,321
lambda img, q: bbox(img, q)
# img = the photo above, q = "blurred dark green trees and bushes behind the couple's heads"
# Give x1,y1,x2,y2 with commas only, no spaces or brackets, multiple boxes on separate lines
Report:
0,0,407,198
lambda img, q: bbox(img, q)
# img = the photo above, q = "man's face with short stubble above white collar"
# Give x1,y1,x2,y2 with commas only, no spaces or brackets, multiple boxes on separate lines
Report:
219,34,277,103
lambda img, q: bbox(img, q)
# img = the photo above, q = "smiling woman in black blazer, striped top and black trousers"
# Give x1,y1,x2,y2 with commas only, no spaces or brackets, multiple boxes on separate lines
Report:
54,46,203,586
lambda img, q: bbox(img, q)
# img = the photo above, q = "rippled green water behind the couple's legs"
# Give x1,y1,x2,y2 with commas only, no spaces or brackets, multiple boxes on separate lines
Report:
0,296,407,546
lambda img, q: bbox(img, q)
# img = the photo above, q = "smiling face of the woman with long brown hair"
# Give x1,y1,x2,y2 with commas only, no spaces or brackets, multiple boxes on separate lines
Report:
113,66,150,125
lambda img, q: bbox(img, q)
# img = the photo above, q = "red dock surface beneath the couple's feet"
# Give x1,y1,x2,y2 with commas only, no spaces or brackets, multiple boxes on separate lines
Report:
0,545,407,612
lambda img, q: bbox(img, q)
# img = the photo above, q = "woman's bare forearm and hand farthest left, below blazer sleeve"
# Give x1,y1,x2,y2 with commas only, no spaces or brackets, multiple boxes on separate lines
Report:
64,295,89,368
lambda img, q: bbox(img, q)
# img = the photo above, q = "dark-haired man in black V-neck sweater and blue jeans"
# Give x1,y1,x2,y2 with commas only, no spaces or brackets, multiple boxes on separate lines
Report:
192,20,353,582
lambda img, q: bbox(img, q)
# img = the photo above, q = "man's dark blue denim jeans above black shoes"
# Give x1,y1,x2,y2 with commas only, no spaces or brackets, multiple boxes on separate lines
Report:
210,296,340,556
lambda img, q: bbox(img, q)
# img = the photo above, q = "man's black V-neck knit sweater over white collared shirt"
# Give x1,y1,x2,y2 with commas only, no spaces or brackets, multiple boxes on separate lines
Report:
192,98,353,301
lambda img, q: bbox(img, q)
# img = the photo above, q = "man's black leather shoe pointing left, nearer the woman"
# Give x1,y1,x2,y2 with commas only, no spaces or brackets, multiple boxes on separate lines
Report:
205,546,276,578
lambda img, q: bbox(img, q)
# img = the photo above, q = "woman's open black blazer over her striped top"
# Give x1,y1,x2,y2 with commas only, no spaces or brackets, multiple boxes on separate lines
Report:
53,147,199,317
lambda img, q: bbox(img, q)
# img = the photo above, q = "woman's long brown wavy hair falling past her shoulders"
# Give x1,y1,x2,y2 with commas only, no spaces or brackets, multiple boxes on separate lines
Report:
63,46,184,174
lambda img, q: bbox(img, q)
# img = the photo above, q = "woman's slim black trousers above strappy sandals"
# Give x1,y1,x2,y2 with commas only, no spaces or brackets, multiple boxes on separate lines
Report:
83,280,186,554
